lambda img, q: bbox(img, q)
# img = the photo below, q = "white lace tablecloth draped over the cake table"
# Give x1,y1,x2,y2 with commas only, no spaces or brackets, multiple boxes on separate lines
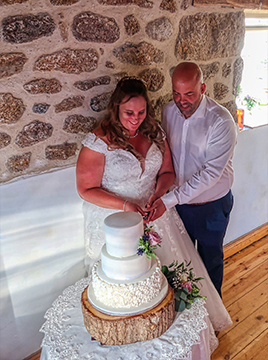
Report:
40,277,218,360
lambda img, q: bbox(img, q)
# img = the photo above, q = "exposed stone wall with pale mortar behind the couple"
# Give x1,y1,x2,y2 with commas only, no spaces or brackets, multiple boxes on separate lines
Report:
0,0,244,182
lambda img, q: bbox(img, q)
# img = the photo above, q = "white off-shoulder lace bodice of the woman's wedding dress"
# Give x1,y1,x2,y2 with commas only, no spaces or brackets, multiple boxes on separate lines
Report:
83,133,162,207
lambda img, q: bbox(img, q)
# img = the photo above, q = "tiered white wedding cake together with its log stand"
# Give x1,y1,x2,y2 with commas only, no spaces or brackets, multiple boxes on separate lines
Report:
82,212,175,345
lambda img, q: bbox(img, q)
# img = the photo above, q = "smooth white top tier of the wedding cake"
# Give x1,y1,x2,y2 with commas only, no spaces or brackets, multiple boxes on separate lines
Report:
104,211,144,257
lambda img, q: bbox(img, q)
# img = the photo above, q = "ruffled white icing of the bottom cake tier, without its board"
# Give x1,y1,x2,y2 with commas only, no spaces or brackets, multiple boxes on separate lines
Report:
92,258,163,308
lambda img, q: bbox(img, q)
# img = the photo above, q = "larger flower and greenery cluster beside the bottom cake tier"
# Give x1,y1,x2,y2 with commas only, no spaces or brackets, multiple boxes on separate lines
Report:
162,261,206,312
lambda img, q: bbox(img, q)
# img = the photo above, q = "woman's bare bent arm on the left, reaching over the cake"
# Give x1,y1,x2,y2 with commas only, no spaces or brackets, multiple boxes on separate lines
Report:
76,147,145,216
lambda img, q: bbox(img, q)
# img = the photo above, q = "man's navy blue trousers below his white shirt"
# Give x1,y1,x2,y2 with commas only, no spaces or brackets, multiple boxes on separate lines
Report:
176,190,233,296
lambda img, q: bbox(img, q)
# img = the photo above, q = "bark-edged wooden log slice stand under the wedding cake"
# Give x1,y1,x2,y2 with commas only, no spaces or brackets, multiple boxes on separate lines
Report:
81,286,175,345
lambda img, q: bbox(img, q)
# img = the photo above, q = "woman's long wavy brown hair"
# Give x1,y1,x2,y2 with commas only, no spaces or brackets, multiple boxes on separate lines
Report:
101,77,165,160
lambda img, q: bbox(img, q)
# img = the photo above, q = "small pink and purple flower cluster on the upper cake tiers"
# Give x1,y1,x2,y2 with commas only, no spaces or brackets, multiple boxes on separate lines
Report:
137,226,161,259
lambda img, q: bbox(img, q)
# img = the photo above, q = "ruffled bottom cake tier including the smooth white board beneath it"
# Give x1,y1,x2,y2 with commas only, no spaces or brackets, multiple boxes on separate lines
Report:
87,258,165,316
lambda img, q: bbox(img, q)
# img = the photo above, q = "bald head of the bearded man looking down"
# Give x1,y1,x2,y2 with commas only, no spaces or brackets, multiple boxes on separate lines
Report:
172,62,206,119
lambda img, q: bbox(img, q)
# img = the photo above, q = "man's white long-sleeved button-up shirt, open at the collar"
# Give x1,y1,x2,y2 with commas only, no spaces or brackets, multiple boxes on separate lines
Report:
161,95,237,209
